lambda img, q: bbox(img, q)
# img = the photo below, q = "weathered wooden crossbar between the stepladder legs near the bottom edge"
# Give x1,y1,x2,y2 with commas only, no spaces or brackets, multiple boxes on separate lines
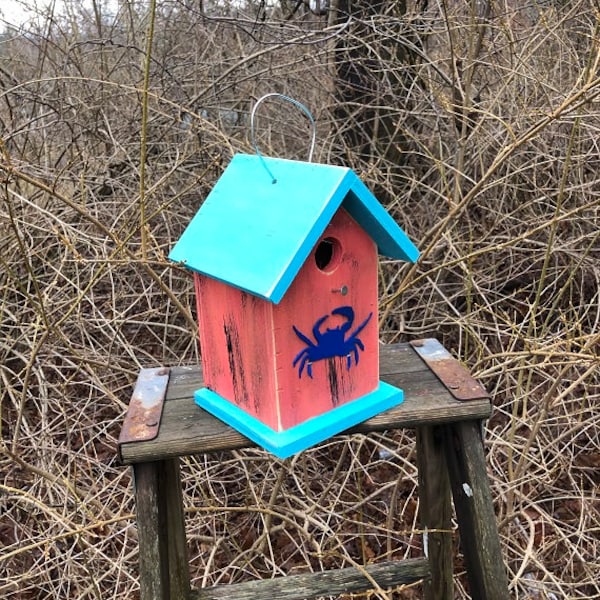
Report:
191,558,430,600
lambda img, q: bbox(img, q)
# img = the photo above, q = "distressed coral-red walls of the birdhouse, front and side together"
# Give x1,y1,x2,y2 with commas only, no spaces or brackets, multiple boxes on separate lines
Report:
195,209,379,431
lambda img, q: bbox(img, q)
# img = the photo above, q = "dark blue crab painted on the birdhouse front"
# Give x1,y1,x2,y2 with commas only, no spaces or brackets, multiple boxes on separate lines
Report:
292,306,373,379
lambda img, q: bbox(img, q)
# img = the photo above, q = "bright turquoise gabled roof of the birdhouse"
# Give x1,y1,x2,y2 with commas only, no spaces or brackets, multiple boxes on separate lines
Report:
169,154,419,303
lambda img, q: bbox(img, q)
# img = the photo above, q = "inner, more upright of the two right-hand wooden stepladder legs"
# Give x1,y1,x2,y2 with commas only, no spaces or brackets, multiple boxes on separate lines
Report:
417,426,454,600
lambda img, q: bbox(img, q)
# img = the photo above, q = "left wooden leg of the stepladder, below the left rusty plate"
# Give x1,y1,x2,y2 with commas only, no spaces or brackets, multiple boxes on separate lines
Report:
133,458,190,600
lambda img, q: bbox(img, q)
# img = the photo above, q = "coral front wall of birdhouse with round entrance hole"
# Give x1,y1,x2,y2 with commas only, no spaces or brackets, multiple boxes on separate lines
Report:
273,209,379,430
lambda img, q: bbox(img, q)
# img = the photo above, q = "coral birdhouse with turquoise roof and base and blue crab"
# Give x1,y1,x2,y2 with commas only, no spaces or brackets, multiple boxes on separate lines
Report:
169,154,419,457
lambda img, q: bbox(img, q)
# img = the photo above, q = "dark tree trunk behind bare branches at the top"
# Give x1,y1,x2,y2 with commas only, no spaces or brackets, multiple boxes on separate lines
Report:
329,0,426,165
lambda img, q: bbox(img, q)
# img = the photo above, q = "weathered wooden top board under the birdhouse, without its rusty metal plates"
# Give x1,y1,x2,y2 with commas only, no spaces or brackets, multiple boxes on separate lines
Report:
120,344,491,464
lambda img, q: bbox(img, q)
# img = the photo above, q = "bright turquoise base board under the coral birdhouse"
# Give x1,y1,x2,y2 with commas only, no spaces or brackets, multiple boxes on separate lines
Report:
194,381,404,458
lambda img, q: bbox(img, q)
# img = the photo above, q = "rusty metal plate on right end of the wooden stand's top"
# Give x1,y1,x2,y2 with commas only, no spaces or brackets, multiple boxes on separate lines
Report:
410,338,490,400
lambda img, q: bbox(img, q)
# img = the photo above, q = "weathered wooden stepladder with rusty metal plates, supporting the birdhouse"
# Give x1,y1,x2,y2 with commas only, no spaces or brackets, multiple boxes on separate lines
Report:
119,339,510,600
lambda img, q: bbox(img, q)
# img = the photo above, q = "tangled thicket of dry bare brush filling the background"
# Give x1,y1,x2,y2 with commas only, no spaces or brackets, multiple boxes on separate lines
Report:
0,0,600,600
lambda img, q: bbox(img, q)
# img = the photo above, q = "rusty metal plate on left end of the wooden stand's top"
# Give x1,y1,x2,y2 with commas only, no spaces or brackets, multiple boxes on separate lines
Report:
119,367,169,448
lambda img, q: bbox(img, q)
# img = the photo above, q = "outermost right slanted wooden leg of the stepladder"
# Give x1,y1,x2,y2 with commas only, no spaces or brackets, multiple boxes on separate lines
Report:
444,421,510,600
